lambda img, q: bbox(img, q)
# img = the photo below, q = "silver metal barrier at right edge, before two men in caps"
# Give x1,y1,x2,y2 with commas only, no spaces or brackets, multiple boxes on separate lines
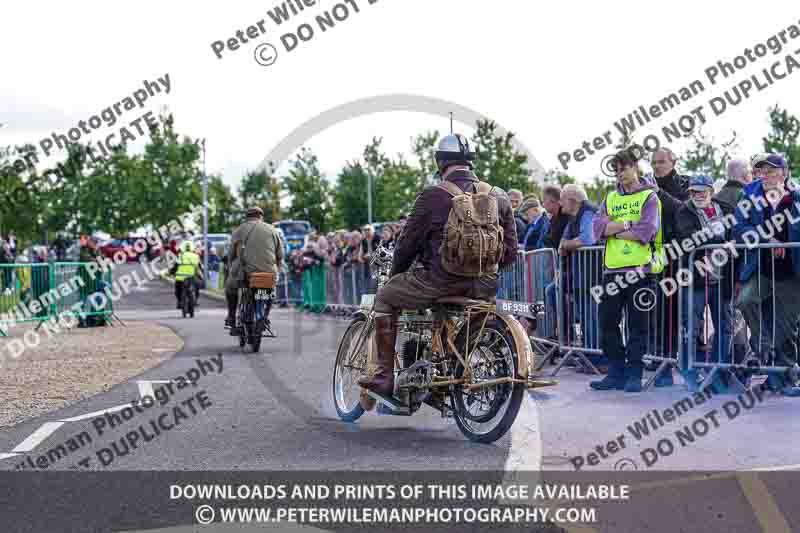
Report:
682,243,800,392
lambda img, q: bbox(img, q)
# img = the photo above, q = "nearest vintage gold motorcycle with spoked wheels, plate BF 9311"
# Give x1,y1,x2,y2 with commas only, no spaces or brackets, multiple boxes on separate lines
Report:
333,247,555,443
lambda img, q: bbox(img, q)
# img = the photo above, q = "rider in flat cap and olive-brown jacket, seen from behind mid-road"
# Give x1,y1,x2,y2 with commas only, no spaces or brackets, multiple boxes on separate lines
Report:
225,207,283,327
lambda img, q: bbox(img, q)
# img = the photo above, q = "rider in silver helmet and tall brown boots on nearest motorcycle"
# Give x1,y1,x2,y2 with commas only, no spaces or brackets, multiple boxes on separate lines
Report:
358,134,517,396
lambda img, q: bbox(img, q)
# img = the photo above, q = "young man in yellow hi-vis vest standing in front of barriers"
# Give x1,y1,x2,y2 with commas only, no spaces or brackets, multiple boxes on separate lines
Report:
590,150,665,392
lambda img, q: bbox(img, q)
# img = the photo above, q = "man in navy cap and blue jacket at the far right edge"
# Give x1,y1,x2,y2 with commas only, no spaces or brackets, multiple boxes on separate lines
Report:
734,154,800,394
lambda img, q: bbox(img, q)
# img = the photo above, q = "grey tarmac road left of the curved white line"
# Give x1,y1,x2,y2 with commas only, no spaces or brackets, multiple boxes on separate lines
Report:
0,267,539,470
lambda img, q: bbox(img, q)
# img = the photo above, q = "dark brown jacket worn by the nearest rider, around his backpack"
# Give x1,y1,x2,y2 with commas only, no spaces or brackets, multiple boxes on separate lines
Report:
392,170,517,279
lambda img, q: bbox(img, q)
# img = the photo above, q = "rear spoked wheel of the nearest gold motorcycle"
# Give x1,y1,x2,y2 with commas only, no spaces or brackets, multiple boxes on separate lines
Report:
453,316,525,443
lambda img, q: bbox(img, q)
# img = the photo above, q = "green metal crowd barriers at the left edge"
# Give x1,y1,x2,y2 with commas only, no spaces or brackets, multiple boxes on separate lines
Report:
0,262,114,337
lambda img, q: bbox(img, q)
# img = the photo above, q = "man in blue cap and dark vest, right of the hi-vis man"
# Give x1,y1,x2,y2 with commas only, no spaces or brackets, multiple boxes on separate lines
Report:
680,175,734,384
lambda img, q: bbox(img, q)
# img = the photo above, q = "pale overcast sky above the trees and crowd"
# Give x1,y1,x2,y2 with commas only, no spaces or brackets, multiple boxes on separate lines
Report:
0,0,800,193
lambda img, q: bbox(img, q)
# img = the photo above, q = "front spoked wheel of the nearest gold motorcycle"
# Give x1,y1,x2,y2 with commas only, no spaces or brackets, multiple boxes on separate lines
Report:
333,316,370,422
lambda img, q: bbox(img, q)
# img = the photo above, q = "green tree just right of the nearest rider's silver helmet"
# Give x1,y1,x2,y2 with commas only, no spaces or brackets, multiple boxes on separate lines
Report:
472,120,535,194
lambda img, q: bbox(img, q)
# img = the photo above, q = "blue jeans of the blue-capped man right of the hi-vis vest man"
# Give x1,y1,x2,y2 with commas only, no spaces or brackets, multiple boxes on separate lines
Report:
682,283,733,368
